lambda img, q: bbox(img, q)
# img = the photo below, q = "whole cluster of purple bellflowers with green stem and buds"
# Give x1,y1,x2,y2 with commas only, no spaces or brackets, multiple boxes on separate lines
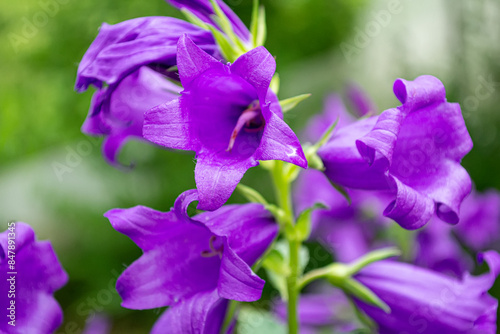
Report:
6,0,500,334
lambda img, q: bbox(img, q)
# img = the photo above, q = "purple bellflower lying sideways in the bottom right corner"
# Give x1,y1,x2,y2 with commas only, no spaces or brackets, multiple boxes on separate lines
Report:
355,251,500,334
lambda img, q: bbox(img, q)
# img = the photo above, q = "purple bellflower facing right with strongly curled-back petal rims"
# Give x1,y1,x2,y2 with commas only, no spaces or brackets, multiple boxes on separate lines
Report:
318,76,472,229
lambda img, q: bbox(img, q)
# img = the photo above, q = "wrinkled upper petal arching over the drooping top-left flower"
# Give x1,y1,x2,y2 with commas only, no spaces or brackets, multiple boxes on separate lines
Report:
76,17,217,92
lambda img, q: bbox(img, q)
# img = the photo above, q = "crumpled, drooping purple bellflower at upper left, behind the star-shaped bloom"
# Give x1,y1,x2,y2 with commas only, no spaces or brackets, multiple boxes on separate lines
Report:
75,17,217,165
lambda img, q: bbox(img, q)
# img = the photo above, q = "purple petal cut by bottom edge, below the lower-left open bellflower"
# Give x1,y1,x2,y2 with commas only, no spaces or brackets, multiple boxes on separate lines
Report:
151,290,227,334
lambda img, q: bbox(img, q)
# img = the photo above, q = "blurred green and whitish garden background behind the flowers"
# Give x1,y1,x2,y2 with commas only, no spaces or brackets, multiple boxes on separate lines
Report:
0,0,500,333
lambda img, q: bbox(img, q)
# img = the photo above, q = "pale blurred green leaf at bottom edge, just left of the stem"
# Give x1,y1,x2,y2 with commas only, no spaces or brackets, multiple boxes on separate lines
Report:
237,306,287,334
